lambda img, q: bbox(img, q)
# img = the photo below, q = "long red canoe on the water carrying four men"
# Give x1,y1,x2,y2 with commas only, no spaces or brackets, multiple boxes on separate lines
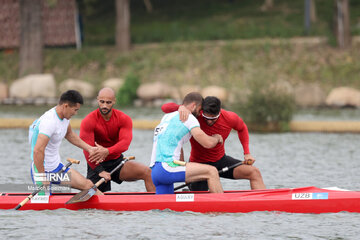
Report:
0,187,360,213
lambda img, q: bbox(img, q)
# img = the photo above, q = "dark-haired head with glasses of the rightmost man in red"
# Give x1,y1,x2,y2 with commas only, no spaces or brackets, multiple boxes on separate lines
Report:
202,96,221,126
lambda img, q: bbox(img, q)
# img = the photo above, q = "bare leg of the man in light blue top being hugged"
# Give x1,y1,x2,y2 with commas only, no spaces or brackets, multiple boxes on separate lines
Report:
185,162,224,193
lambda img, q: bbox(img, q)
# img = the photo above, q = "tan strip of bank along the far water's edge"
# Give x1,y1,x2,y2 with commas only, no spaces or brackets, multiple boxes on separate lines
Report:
0,118,360,133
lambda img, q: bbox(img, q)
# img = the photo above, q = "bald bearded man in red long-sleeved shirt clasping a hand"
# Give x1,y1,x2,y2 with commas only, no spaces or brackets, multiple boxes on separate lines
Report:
80,88,155,192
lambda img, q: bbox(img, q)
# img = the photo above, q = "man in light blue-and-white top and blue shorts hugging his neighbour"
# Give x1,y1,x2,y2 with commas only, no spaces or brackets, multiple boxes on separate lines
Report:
150,92,223,194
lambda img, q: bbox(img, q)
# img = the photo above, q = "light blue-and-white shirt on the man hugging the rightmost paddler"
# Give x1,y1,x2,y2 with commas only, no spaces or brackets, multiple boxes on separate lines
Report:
150,112,200,167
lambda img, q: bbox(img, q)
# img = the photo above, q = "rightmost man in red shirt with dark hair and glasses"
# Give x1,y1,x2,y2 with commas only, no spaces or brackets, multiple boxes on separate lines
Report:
162,96,266,191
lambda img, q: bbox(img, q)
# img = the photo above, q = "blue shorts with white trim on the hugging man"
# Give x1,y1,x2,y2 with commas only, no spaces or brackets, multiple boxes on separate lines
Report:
151,162,186,194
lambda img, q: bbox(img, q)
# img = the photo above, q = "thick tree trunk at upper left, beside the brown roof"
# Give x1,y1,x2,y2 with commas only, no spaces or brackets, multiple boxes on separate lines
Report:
19,0,43,76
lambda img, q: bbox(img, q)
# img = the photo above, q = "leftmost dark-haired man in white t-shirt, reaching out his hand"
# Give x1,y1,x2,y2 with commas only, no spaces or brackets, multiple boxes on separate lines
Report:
29,90,102,195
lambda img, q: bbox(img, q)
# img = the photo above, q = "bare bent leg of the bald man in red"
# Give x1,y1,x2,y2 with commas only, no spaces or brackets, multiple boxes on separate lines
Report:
119,161,155,192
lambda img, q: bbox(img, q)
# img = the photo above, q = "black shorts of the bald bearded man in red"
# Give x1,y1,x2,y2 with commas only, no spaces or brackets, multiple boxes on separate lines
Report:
86,155,124,192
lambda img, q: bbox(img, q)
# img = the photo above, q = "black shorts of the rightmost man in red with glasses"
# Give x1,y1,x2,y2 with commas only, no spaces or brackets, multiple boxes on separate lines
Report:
189,155,241,191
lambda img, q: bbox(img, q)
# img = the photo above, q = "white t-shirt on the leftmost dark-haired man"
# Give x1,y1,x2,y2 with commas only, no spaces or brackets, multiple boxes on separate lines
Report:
29,107,70,171
